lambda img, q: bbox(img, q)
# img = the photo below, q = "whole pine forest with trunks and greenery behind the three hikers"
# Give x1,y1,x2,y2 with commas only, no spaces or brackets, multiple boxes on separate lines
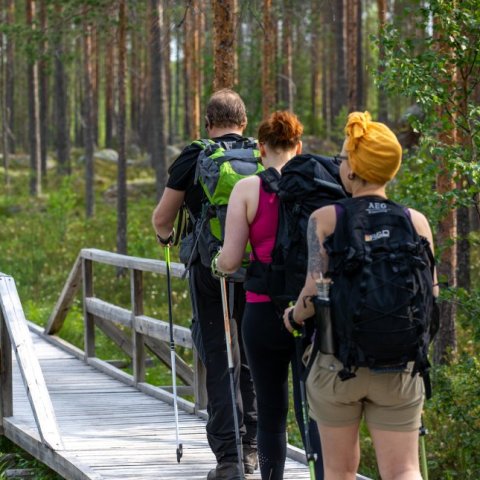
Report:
0,0,480,479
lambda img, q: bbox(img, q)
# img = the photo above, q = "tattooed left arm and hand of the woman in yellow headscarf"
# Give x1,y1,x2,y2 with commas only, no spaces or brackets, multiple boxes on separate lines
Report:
283,206,336,332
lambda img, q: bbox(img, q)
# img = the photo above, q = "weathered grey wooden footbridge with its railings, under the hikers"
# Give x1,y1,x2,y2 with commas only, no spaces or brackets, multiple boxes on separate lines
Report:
0,249,368,480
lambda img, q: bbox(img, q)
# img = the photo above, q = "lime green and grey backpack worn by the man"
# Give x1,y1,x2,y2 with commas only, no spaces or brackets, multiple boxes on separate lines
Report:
187,138,264,274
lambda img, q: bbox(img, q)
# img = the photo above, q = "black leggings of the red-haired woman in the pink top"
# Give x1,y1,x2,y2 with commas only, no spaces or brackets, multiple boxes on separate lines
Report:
242,302,323,480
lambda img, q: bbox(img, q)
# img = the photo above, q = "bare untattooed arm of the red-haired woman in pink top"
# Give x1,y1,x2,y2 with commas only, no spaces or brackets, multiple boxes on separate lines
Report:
217,177,259,273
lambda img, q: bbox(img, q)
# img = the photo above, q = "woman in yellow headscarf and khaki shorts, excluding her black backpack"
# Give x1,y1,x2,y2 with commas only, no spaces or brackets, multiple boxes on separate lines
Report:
284,112,438,480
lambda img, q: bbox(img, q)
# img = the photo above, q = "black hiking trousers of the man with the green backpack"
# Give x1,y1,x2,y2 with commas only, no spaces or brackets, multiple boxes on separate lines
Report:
190,262,257,462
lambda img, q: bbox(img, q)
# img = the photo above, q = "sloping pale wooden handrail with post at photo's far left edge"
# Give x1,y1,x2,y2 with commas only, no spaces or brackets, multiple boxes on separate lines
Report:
0,273,63,450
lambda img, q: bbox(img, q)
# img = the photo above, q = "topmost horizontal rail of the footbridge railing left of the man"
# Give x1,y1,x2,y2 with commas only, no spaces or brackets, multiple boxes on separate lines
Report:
80,248,185,278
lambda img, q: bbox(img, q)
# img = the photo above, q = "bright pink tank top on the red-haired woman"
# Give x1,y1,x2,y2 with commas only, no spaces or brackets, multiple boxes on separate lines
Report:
247,179,278,303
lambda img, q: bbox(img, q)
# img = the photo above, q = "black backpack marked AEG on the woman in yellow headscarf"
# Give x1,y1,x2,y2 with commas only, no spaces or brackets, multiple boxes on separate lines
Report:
324,196,437,398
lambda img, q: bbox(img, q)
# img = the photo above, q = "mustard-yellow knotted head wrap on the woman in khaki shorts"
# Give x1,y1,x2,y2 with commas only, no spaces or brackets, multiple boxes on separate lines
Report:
345,112,402,184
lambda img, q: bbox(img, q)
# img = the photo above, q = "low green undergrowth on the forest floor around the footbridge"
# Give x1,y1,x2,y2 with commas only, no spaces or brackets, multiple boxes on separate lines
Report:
0,152,480,480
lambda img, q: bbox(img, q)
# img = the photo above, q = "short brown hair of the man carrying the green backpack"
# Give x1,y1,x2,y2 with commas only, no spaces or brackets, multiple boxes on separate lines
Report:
206,88,247,129
